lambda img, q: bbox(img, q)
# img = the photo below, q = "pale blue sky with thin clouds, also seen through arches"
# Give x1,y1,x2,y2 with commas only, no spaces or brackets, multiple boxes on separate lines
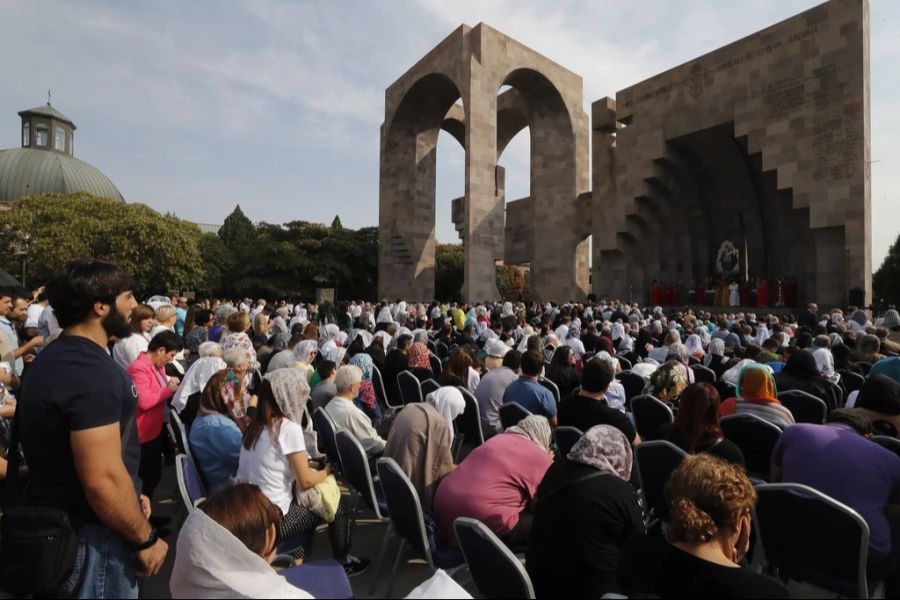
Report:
0,0,900,268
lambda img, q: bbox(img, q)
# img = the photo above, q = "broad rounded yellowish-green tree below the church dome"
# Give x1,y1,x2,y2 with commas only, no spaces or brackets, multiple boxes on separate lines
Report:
0,193,206,294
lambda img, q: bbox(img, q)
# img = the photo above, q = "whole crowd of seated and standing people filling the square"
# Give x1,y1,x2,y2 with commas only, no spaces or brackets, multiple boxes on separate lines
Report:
0,260,900,597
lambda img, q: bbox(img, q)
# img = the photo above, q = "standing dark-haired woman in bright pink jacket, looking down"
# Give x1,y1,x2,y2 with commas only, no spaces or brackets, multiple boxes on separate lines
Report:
127,330,184,500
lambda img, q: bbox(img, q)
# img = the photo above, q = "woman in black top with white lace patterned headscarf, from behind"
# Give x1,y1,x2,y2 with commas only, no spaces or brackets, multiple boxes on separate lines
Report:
525,425,644,598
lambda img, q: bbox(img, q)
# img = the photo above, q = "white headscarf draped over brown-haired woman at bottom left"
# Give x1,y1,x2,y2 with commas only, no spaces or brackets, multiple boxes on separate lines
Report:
169,510,312,598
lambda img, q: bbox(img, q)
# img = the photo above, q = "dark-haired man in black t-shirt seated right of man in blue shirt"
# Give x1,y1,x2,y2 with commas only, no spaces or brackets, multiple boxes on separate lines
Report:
558,359,641,445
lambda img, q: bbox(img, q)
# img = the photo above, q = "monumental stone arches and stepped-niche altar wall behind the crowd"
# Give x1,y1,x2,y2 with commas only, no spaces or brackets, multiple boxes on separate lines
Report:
379,0,871,304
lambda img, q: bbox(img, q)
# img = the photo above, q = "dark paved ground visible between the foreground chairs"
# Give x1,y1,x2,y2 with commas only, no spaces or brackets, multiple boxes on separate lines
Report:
143,466,474,598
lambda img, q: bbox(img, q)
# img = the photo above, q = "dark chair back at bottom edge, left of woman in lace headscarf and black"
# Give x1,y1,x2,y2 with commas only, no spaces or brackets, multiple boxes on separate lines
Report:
453,517,535,598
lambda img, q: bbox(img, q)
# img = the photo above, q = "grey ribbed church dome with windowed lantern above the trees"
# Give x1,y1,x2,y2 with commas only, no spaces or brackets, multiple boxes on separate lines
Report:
0,102,125,202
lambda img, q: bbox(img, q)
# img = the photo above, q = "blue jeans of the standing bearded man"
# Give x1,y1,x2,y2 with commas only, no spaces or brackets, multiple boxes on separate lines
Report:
59,523,139,598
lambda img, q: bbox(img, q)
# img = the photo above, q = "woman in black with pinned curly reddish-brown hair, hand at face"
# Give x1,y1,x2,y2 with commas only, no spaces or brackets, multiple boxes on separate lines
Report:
619,454,788,598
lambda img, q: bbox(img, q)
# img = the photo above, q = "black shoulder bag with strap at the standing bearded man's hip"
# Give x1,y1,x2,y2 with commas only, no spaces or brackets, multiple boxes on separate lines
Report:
0,407,134,595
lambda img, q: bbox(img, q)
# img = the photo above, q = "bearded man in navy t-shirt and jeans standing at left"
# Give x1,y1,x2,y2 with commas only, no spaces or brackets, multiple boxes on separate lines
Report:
18,259,168,598
